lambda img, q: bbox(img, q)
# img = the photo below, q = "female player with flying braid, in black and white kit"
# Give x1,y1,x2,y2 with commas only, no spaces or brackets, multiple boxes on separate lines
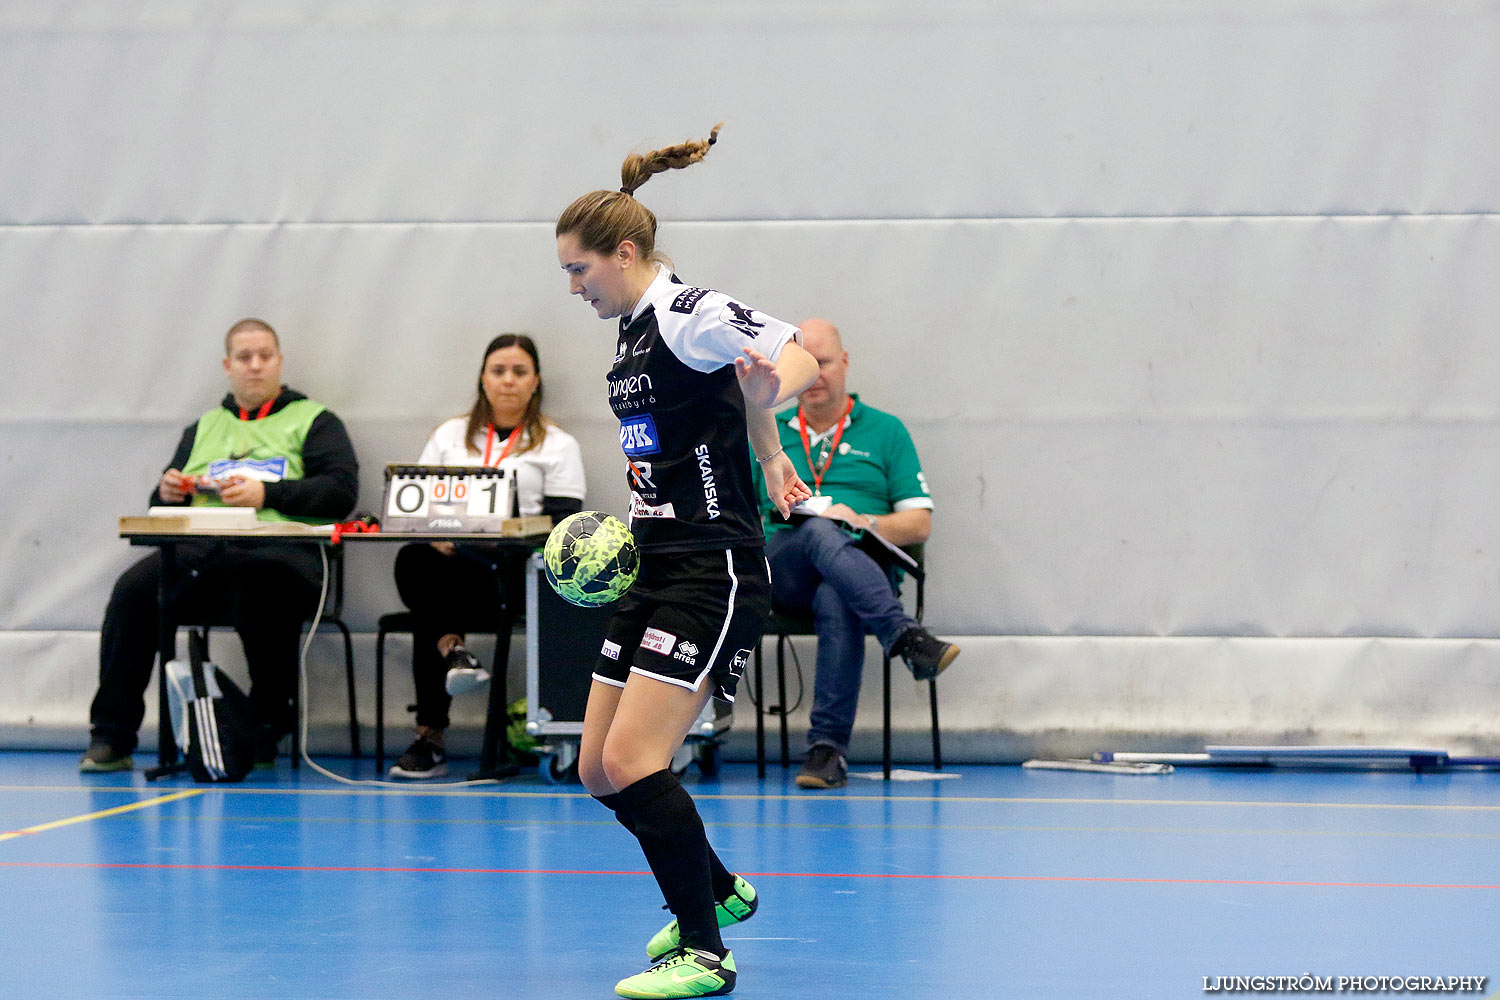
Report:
557,126,818,997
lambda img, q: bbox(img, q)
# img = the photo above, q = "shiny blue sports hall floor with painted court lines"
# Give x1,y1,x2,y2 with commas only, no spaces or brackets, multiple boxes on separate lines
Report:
0,753,1500,1000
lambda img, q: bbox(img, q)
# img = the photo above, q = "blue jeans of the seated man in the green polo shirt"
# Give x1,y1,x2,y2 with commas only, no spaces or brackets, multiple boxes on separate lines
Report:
765,517,917,754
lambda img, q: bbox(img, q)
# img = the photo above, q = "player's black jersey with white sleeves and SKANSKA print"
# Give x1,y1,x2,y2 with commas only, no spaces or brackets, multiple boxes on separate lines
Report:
609,267,803,552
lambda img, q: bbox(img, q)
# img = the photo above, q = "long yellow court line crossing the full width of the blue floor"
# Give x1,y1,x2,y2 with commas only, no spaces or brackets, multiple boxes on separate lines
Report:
0,783,1500,813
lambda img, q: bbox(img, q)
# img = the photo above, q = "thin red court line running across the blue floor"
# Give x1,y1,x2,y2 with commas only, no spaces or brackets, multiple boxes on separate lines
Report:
0,861,1500,891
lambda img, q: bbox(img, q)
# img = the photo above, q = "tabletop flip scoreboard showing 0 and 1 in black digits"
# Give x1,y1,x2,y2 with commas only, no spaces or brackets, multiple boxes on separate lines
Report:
380,465,519,532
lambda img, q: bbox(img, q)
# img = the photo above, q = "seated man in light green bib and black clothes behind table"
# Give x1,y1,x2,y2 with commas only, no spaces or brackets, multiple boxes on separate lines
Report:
80,319,359,771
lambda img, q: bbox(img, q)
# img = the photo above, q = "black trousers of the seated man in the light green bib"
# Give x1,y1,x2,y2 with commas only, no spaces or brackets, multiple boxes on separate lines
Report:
89,543,323,753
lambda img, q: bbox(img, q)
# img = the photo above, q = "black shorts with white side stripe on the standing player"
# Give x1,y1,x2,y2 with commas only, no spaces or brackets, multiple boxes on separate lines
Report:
594,547,771,702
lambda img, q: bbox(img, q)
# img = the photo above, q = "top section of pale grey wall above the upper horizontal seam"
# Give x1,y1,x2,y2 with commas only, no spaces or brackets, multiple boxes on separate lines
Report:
0,0,1500,223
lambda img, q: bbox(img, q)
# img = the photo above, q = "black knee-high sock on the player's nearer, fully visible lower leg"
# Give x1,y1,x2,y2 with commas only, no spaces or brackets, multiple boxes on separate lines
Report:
617,769,725,955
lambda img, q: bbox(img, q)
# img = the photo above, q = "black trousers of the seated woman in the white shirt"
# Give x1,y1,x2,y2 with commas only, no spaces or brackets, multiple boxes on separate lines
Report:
396,543,525,729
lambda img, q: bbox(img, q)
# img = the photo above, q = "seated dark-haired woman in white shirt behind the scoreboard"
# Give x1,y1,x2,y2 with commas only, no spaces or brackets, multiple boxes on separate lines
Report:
390,333,584,778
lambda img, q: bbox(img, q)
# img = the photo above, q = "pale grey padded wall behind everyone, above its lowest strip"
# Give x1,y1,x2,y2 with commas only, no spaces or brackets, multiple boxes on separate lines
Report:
0,0,1500,749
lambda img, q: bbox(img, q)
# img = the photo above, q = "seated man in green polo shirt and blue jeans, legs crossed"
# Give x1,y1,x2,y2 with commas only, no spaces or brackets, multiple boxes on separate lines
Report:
759,319,959,789
